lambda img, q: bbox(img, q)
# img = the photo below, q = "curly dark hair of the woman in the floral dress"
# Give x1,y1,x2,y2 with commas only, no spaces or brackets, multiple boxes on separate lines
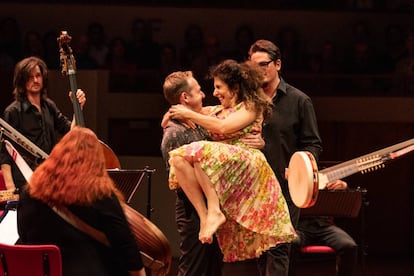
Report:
210,59,273,120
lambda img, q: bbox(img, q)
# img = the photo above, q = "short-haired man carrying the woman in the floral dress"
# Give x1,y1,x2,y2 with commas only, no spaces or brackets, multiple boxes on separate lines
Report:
161,71,223,276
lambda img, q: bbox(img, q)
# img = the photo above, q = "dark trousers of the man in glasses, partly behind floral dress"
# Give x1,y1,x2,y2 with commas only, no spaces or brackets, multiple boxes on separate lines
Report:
258,201,300,276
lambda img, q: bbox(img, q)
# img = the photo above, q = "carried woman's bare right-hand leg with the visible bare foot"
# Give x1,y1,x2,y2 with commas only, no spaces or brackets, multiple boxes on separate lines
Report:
193,162,226,243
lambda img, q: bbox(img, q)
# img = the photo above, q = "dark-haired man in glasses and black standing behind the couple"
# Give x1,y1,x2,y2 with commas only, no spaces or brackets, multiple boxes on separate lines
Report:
249,40,322,276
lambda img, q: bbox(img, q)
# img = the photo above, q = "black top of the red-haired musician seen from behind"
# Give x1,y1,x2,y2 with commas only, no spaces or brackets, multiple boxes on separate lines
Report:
17,189,143,276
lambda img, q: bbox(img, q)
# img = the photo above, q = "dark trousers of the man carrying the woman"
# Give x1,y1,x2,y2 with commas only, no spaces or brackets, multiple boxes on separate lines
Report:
175,190,223,276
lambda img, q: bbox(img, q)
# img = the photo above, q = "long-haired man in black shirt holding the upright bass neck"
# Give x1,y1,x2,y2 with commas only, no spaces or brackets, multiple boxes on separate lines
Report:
0,57,86,190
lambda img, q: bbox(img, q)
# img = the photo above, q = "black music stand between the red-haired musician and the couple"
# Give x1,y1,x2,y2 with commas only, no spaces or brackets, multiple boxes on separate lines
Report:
107,167,155,219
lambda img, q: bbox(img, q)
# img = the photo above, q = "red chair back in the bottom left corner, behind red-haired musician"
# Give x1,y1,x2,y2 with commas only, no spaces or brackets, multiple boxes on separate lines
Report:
0,244,62,276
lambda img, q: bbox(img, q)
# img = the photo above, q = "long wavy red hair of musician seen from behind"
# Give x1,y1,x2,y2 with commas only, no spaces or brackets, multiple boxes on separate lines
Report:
27,126,123,206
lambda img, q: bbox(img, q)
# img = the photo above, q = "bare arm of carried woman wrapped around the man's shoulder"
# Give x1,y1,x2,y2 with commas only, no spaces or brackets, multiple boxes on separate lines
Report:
170,105,257,134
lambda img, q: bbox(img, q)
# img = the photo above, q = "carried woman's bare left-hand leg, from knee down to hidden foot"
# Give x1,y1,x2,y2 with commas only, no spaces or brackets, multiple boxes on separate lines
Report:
170,156,207,231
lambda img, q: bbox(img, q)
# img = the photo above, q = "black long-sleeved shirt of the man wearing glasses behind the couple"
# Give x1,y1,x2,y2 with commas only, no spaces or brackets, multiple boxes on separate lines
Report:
263,79,322,200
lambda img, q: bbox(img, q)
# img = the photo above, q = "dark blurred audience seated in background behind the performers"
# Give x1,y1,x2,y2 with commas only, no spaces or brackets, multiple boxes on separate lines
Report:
0,11,412,96
